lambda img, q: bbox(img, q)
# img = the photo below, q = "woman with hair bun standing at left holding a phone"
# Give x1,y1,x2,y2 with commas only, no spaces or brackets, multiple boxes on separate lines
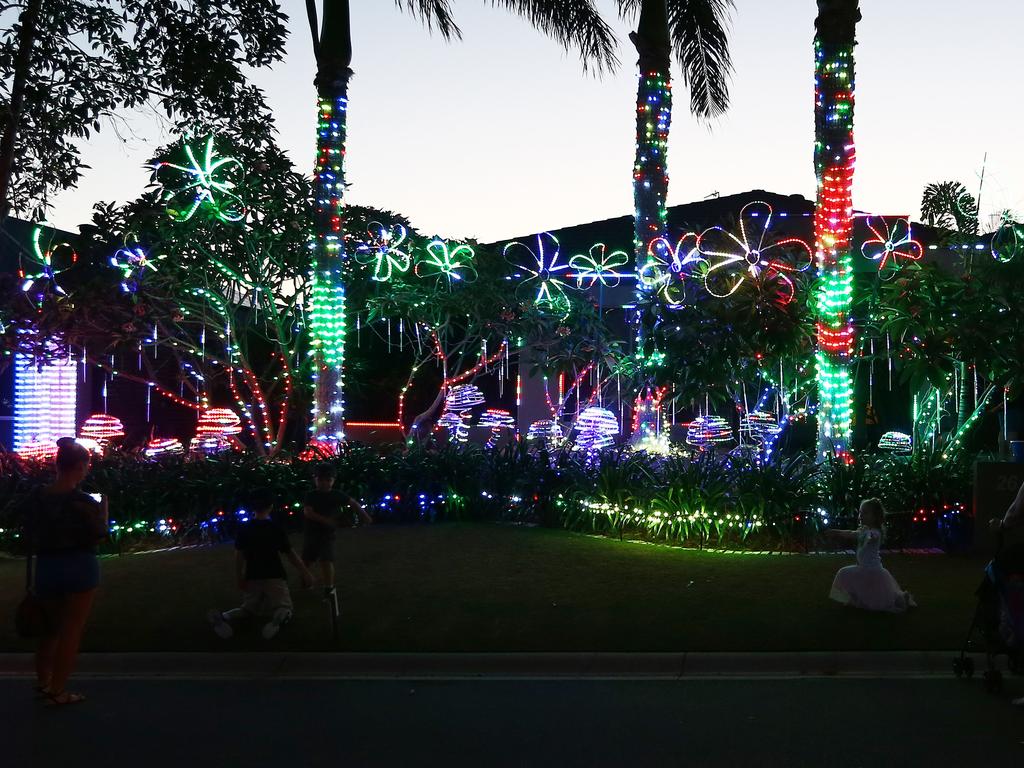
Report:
27,437,108,706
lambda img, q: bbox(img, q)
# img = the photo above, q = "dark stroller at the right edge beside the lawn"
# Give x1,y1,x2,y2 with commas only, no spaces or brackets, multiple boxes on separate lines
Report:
952,535,1024,693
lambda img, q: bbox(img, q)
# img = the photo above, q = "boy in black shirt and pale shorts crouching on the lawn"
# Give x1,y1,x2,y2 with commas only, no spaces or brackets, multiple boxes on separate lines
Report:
208,490,313,640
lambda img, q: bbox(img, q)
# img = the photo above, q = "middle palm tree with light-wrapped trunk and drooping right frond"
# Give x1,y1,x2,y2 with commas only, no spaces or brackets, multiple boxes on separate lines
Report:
618,0,733,437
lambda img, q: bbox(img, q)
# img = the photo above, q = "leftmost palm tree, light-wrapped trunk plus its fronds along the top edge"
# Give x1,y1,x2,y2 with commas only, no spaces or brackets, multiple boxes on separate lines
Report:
306,0,615,439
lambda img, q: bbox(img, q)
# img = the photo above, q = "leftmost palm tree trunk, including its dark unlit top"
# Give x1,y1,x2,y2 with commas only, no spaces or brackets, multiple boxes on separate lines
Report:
309,0,352,440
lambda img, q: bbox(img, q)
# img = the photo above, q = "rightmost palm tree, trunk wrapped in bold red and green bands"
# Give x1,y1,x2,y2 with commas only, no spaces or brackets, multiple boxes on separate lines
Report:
814,0,860,461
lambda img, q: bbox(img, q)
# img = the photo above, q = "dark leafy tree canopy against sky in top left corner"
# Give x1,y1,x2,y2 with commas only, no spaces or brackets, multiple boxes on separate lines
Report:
0,0,287,222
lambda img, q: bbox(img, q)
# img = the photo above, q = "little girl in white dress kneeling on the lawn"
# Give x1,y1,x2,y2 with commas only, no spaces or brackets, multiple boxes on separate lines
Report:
829,499,918,613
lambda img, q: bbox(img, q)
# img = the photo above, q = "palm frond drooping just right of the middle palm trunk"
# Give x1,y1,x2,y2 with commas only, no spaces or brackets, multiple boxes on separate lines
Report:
667,0,734,118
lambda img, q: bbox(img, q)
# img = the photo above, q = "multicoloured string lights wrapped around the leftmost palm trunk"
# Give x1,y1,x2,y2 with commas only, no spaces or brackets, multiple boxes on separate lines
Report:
309,94,348,441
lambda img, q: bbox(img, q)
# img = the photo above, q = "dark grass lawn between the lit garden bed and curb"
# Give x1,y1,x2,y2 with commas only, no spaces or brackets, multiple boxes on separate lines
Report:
0,523,983,651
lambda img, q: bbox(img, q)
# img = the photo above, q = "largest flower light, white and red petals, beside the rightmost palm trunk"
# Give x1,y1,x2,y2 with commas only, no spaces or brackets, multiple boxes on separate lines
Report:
697,201,813,306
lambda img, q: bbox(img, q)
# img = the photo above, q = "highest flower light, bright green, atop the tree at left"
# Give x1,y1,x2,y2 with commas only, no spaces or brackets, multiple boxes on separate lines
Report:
154,136,246,221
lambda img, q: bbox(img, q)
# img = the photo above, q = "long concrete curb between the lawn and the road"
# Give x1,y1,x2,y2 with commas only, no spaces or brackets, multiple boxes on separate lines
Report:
0,651,956,680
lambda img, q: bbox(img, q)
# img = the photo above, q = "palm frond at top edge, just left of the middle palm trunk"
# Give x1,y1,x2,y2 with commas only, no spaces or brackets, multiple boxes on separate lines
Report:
490,0,618,72
